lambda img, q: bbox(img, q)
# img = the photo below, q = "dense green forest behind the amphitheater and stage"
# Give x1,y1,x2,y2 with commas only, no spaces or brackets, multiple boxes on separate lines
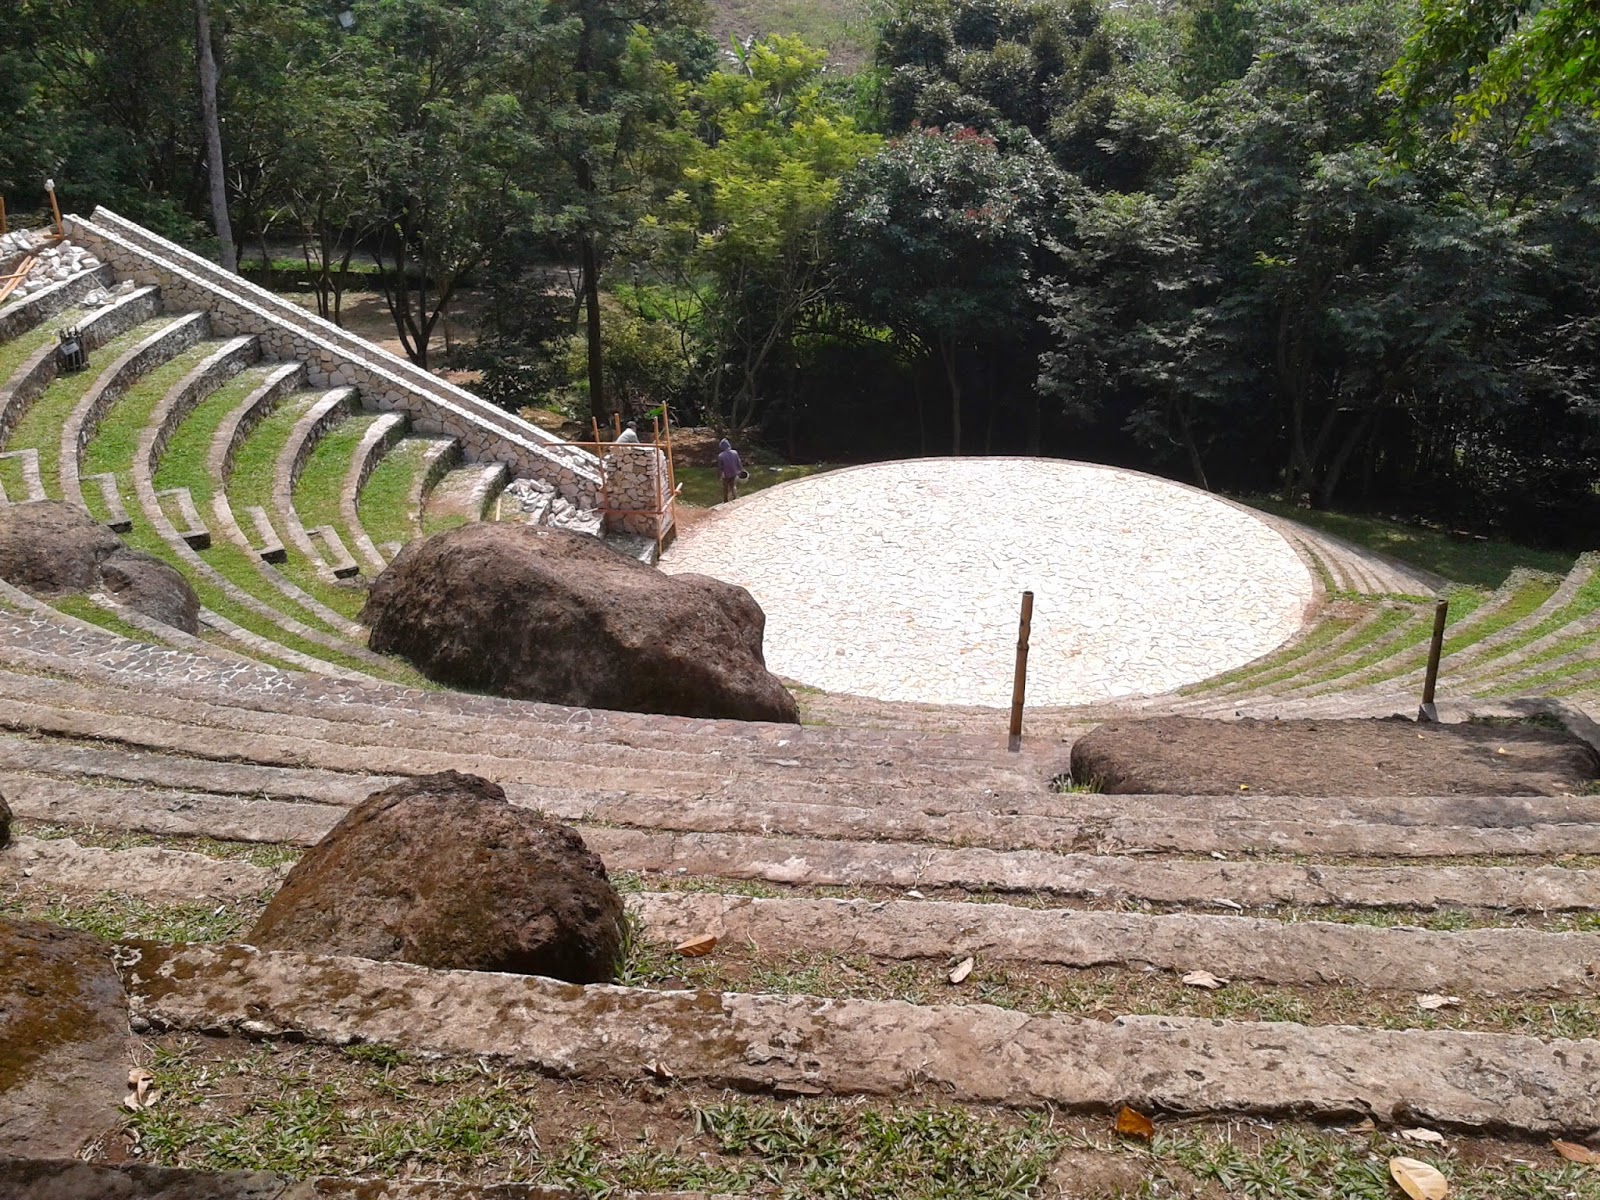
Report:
0,0,1600,549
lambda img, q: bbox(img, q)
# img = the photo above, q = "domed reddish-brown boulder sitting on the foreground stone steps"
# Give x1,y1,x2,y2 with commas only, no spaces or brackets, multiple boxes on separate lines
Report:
248,771,622,984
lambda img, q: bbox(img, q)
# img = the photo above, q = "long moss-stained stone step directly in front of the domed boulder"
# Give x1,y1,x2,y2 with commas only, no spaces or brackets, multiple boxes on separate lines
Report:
128,944,1600,1134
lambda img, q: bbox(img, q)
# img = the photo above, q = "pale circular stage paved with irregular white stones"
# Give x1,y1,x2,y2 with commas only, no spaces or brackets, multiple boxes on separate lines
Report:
661,458,1314,707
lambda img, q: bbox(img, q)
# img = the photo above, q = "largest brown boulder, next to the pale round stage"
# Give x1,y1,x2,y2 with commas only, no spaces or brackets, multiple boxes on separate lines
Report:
362,523,798,722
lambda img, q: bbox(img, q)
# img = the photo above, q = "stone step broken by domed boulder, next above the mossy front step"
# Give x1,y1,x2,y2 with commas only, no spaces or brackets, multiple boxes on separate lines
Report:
12,825,1600,997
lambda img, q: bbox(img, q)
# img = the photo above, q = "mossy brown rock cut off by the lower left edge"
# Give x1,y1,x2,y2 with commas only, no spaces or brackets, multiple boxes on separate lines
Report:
0,917,131,1158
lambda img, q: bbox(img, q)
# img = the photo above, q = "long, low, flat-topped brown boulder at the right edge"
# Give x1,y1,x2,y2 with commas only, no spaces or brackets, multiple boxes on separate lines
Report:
1072,717,1600,795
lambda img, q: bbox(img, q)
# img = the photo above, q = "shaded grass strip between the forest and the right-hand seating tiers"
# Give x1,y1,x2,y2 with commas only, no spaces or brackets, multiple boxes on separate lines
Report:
1238,496,1578,590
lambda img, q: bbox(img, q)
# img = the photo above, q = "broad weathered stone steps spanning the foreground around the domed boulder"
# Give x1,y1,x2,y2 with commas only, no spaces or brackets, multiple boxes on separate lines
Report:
0,598,1600,1195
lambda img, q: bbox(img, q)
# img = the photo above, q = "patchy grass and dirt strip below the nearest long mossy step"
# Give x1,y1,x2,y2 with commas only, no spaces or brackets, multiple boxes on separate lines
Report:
116,1037,1600,1200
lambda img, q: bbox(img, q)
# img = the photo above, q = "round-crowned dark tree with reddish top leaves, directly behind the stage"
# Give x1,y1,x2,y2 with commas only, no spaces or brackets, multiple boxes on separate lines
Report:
835,125,1066,454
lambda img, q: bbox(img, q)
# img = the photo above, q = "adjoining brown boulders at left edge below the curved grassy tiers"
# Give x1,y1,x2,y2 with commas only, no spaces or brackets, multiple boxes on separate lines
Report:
0,501,200,634
